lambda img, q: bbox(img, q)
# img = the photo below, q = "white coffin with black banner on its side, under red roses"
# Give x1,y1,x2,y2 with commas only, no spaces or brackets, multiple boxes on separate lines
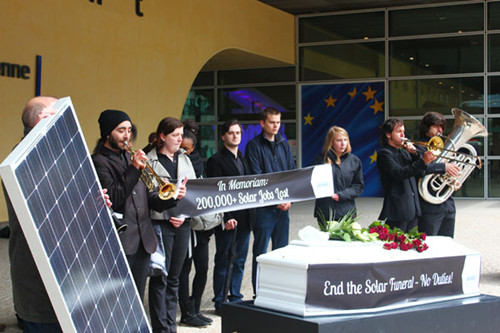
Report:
254,236,480,316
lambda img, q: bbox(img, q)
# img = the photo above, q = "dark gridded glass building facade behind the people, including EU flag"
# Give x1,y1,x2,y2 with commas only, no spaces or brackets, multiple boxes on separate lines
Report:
187,1,500,199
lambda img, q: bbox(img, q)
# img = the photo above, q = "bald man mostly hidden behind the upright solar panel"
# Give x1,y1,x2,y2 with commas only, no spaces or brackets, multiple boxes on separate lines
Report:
4,96,62,333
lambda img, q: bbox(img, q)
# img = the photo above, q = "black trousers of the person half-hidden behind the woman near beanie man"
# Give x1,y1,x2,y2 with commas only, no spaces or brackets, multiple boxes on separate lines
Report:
179,230,213,304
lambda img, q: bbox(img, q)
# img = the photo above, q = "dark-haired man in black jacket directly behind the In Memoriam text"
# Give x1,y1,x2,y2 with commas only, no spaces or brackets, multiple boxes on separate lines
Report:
207,119,255,313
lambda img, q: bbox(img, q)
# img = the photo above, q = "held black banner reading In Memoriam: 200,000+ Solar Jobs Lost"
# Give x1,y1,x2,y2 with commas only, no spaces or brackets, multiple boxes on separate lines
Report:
166,165,333,217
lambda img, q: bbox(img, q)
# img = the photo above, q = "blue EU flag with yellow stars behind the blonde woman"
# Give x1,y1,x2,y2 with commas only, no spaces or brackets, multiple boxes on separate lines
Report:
301,82,384,197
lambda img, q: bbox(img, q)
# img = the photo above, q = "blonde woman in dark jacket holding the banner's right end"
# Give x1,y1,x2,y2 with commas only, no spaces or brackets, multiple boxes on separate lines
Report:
314,126,364,225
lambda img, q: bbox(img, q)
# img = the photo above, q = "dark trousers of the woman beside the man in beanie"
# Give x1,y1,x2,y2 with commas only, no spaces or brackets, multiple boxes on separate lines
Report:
149,221,191,333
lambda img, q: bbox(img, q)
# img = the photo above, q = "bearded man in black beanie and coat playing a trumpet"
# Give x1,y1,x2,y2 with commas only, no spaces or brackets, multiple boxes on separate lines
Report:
92,110,186,300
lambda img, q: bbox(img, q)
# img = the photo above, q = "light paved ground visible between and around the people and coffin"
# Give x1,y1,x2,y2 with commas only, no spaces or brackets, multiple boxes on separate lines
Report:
0,198,500,333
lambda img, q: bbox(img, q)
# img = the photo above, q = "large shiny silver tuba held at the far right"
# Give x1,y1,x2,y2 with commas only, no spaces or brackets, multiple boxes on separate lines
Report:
418,108,488,204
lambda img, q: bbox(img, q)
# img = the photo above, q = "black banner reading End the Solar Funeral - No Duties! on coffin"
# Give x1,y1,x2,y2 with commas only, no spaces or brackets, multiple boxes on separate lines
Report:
305,256,465,310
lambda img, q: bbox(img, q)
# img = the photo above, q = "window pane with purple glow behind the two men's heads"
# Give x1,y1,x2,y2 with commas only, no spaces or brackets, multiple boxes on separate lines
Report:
219,85,296,121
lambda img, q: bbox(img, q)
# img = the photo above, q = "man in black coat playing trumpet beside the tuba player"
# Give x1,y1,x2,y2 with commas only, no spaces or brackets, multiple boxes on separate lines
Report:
377,118,436,232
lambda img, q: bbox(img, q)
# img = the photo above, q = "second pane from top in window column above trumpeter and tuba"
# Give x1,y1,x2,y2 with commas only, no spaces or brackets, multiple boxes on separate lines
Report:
389,36,483,76
